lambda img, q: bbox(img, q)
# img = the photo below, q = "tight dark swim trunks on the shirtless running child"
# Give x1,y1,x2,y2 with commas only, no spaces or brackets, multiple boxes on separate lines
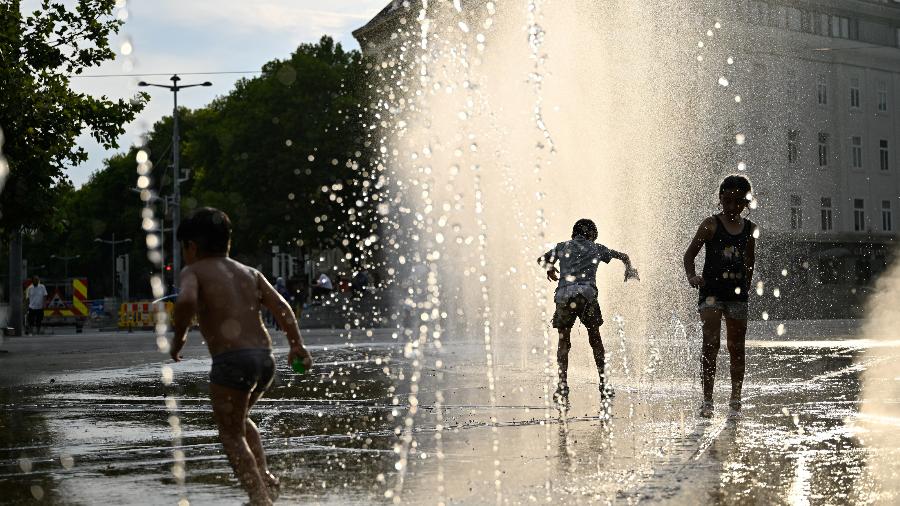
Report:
209,348,275,392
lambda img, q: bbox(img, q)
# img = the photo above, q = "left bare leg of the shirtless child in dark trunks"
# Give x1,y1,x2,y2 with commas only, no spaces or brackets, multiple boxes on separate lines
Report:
209,383,272,505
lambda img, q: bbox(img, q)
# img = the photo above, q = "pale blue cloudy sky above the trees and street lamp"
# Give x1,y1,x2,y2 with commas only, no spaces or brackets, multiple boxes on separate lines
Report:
59,0,389,186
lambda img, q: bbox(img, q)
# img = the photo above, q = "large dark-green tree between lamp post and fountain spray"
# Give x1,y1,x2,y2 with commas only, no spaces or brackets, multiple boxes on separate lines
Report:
182,37,369,259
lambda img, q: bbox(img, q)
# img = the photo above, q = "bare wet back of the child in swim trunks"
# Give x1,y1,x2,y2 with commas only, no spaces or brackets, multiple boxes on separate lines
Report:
185,257,272,355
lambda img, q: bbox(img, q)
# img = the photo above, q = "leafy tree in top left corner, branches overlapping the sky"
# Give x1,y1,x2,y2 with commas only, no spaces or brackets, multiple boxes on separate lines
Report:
0,0,147,235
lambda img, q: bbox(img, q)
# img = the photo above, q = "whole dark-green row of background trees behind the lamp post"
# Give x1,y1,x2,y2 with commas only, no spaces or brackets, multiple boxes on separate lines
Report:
26,37,375,296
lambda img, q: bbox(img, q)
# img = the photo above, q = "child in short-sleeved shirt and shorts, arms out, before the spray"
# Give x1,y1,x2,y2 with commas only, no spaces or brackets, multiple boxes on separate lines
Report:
538,219,639,403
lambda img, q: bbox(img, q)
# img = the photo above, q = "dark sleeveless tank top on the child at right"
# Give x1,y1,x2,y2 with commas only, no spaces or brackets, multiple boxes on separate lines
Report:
700,215,756,302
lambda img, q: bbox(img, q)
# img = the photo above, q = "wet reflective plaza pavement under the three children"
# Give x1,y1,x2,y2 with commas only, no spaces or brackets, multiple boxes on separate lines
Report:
0,322,900,504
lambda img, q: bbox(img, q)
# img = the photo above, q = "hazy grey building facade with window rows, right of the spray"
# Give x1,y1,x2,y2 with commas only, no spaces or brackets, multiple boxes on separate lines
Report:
733,0,900,317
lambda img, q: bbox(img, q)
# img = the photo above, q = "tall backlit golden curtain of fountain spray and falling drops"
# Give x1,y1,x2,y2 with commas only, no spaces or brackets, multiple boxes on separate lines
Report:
358,0,749,502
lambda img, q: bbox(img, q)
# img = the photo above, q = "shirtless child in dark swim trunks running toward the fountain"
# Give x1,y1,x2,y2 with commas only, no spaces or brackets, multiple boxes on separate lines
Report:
170,207,312,504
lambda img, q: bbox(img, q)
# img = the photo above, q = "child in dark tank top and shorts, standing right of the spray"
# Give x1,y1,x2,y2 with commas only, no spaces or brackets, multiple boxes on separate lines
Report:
684,175,759,418
